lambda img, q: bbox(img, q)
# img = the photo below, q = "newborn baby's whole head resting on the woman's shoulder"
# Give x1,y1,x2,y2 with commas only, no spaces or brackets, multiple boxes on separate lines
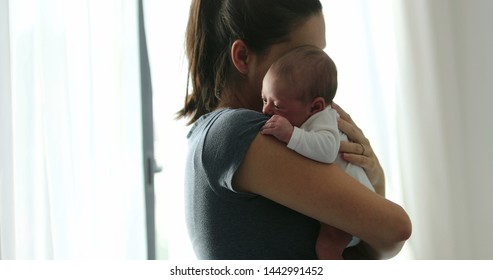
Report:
262,46,337,126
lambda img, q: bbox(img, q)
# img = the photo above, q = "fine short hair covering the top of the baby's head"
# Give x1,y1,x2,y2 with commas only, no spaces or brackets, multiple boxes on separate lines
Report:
269,45,337,104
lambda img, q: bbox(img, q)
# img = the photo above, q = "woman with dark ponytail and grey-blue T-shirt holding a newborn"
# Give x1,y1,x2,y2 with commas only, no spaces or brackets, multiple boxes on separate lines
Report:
180,0,411,259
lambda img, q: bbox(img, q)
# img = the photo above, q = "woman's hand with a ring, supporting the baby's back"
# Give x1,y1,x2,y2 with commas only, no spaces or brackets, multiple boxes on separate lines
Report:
332,103,385,196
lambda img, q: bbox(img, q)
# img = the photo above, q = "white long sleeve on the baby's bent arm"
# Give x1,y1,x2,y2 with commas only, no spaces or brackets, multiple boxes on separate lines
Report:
288,106,340,163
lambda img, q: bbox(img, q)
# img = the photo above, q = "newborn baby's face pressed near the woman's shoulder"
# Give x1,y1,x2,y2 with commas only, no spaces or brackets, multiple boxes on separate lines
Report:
262,70,312,127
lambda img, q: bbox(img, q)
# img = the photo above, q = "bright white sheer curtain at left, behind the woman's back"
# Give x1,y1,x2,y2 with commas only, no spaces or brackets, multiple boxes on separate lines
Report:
0,0,146,259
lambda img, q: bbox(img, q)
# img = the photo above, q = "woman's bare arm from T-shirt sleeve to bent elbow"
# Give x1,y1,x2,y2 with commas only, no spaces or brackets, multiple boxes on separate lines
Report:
234,134,411,258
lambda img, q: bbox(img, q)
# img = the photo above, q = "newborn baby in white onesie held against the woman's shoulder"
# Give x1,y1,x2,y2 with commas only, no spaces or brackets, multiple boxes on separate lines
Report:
261,46,374,259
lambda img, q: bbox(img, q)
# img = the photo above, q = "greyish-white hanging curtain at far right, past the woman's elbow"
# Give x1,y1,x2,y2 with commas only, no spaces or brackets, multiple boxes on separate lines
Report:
396,0,493,259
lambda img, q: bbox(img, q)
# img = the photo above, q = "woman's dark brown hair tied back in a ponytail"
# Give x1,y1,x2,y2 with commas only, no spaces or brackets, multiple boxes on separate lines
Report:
178,0,322,123
